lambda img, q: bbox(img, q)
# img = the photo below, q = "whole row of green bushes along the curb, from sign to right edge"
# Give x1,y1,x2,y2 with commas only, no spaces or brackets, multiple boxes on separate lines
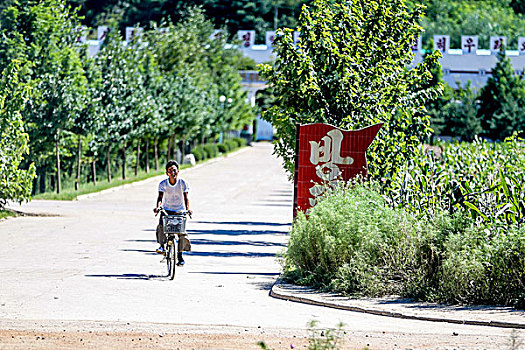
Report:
283,185,525,307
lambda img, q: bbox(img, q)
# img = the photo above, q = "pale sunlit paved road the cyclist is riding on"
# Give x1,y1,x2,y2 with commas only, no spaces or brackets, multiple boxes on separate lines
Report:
0,143,510,348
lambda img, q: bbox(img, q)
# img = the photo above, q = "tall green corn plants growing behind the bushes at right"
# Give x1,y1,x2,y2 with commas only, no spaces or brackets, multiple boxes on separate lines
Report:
383,133,525,231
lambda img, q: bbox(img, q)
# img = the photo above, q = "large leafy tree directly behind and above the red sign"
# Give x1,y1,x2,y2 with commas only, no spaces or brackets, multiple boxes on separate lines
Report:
261,0,439,181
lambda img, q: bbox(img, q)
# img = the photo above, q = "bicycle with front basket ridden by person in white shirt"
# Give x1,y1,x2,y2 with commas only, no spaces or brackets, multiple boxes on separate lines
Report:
155,207,191,280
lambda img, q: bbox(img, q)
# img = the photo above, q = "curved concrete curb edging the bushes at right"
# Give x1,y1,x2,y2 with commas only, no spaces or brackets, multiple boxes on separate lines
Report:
270,278,525,329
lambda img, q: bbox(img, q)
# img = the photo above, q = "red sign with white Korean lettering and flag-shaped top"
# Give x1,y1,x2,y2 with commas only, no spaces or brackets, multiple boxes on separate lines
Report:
294,124,383,217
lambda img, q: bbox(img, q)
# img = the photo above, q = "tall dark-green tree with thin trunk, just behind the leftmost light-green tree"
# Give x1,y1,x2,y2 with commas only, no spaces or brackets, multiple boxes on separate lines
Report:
0,0,85,192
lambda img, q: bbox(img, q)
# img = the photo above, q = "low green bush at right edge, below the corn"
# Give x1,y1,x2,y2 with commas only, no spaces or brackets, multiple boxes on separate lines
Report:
439,227,525,308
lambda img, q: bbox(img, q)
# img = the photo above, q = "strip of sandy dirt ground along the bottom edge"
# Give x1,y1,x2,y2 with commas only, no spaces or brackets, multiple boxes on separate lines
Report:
0,326,523,350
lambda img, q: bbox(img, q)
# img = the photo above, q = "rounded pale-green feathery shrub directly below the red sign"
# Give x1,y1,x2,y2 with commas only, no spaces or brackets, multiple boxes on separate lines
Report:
285,182,424,296
